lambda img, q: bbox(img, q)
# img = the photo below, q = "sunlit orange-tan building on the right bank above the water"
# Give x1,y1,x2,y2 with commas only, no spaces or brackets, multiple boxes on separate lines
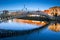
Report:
44,6,60,16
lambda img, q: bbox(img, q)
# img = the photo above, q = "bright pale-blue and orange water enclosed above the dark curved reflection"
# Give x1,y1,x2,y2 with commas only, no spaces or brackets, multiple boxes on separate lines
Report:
0,19,47,30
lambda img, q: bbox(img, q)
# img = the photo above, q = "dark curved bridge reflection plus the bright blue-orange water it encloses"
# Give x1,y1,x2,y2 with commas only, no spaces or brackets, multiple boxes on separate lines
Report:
0,19,47,38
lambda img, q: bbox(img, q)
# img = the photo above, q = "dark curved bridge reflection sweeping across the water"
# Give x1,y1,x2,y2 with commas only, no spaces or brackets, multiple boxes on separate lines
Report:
0,24,49,38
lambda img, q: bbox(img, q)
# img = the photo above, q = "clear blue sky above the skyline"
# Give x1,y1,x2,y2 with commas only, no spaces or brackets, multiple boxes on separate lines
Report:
0,0,60,10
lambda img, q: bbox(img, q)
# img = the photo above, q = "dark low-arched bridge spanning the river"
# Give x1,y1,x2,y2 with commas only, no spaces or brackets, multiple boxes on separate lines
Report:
0,11,53,21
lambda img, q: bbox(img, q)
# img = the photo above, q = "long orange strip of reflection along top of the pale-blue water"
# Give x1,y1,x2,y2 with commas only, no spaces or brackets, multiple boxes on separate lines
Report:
13,19,47,26
